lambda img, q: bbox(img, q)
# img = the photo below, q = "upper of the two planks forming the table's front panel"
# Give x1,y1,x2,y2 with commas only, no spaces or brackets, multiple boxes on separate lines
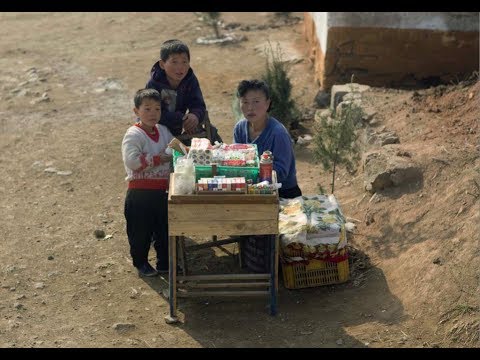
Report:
168,204,278,223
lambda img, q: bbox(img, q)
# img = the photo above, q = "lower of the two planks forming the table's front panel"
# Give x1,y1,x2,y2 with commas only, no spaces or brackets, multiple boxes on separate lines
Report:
168,216,278,236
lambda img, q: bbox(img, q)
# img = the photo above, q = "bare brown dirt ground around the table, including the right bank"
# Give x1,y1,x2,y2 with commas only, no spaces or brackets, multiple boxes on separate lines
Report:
0,13,480,348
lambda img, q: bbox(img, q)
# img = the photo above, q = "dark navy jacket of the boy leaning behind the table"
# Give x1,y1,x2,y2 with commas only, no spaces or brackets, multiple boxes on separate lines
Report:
145,62,206,136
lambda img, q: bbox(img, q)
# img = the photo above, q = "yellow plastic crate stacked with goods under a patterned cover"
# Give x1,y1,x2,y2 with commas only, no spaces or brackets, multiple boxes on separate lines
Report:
279,195,349,289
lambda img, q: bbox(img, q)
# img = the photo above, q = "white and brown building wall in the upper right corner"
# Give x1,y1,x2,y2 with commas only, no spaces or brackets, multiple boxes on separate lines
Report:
304,12,479,89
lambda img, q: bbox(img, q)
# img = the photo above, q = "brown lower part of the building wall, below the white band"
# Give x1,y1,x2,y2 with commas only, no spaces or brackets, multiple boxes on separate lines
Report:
304,13,479,89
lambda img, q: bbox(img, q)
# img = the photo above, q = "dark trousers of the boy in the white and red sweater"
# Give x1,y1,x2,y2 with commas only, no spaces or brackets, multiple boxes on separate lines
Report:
124,189,168,269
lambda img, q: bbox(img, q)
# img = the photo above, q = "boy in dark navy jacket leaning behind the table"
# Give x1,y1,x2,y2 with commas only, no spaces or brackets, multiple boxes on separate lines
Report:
145,39,206,136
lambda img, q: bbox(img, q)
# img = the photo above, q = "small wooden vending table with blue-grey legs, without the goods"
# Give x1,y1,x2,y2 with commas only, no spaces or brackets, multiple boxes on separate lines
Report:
165,174,279,323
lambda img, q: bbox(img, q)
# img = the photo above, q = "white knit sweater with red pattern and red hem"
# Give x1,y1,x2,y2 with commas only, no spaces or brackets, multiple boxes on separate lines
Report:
122,123,173,190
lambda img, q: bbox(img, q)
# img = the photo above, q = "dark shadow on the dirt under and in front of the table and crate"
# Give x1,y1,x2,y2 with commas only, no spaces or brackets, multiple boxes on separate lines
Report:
145,240,405,348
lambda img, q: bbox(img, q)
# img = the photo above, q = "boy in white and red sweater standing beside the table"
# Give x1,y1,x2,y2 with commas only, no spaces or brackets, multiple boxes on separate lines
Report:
122,89,173,276
